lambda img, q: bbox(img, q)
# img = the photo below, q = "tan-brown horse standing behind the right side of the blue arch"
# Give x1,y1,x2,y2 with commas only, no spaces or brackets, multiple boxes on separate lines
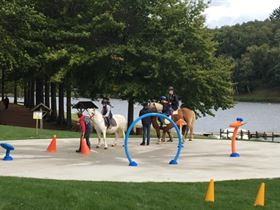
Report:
149,103,196,142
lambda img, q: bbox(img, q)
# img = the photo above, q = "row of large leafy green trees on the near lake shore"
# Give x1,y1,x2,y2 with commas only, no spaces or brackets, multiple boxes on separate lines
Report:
0,0,233,126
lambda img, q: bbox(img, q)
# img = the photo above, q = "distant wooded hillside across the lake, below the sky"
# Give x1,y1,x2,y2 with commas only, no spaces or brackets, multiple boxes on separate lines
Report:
213,7,280,93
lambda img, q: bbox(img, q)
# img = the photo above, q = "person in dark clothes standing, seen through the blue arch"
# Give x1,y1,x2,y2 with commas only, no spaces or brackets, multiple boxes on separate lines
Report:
139,102,152,146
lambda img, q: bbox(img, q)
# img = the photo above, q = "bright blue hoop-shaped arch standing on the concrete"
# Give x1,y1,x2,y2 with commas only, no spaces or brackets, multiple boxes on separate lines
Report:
124,113,183,166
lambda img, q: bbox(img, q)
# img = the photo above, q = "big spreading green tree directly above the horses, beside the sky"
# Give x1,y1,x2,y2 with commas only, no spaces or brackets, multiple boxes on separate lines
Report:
77,0,232,122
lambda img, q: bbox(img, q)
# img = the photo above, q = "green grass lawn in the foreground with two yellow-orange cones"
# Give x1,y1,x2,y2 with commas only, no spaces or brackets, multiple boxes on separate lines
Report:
0,177,280,210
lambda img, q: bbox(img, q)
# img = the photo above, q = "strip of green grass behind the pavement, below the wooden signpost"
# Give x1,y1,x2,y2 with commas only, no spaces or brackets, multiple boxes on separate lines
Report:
0,125,79,140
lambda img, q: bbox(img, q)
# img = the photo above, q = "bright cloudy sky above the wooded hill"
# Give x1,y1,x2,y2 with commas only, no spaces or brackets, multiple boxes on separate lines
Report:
205,0,280,28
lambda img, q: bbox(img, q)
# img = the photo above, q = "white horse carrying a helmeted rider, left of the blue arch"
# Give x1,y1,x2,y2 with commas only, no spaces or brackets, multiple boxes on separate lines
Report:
88,109,127,149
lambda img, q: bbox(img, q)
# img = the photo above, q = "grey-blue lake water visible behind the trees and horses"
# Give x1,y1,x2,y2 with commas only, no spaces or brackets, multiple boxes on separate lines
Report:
11,98,280,133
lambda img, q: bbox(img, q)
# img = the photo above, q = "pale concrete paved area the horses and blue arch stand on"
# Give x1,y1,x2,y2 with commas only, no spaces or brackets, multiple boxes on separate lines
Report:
0,139,280,182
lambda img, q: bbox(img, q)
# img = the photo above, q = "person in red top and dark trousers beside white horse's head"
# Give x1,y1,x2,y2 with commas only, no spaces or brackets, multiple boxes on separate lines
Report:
76,112,92,152
